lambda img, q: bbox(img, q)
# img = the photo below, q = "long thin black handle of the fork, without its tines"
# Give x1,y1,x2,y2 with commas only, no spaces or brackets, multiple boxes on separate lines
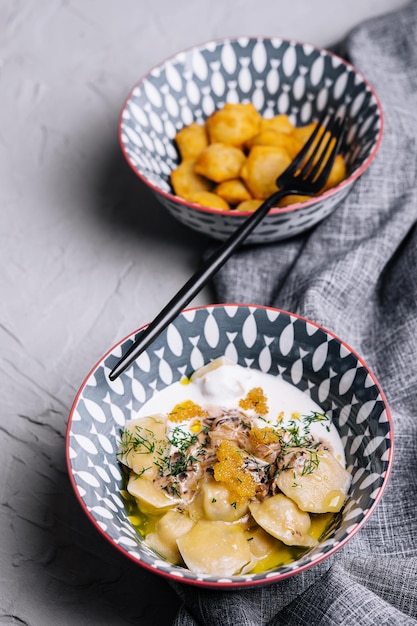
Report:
109,190,291,380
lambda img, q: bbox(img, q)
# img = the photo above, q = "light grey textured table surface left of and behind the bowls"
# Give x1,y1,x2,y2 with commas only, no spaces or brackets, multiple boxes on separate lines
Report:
0,0,407,626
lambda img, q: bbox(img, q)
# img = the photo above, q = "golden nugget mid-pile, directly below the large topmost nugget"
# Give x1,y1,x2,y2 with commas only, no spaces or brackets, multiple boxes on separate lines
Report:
194,143,246,183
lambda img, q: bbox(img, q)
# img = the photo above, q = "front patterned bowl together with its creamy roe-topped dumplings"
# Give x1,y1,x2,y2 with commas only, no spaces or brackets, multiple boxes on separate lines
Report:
66,304,393,589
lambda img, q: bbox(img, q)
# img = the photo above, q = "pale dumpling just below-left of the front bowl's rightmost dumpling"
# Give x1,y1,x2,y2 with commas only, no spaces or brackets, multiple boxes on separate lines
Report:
249,493,315,547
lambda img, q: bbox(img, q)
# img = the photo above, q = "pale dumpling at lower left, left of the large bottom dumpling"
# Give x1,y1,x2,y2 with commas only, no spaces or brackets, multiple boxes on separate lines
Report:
145,510,194,565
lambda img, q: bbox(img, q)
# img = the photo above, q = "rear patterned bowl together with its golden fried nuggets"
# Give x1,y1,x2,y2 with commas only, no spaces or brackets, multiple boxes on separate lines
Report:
119,37,383,244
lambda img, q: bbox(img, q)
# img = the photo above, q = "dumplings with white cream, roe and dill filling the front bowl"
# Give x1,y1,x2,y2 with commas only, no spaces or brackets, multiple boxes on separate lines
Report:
119,357,351,576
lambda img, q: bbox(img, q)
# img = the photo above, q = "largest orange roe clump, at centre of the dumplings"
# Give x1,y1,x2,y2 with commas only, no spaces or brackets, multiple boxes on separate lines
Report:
213,439,256,504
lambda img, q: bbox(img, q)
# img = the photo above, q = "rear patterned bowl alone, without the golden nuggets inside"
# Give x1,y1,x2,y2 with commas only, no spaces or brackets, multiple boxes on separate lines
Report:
119,37,383,243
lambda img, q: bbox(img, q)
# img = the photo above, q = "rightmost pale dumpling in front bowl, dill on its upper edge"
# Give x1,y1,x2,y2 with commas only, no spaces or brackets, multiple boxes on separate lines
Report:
276,450,351,513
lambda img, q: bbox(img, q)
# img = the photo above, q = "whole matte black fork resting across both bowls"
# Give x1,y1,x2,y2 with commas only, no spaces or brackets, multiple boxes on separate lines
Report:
109,114,346,380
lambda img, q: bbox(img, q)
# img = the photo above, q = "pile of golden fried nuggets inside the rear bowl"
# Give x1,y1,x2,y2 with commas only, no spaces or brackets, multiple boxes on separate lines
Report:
171,103,347,211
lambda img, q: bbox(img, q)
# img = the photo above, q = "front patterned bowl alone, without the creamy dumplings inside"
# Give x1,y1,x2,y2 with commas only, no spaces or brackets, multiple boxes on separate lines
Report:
67,305,393,589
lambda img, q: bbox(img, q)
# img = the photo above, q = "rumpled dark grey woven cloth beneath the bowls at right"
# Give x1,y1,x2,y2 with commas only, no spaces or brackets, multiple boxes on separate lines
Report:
172,1,417,626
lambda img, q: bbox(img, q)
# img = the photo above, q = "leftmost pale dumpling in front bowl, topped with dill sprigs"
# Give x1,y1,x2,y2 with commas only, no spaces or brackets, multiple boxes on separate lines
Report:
119,415,169,478
